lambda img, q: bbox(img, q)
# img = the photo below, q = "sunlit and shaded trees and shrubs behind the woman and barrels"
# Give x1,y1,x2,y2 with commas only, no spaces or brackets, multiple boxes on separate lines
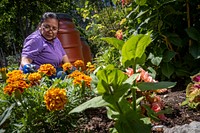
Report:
0,0,200,85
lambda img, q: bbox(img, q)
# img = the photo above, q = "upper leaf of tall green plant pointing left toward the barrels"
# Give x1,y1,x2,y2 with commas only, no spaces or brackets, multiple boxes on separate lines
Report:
101,37,124,50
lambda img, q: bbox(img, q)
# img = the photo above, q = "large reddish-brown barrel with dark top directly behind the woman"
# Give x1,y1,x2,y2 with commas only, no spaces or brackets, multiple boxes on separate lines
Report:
57,13,84,63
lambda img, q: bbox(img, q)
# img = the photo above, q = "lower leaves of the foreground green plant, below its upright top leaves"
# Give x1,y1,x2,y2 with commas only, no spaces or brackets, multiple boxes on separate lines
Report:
70,66,175,133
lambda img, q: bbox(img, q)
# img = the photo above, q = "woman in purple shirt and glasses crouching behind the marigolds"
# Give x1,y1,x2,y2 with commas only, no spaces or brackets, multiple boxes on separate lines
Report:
20,12,69,73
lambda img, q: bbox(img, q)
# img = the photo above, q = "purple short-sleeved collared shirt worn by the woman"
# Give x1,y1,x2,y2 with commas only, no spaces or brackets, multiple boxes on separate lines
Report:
20,30,66,69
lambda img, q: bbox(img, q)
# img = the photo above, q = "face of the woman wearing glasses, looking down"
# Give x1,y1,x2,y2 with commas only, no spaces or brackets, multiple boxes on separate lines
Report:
39,18,58,41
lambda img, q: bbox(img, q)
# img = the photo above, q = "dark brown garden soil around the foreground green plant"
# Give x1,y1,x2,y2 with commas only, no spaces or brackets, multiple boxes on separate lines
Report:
70,89,200,133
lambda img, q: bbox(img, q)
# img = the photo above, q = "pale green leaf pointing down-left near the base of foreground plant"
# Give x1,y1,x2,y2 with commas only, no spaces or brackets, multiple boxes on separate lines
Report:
69,96,109,114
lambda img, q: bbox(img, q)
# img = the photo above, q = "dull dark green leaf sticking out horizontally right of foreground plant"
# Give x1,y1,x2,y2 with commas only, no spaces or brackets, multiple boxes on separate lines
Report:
137,81,176,91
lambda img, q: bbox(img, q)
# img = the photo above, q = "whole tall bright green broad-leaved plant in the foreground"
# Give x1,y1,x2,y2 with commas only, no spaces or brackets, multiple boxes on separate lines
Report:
69,34,175,133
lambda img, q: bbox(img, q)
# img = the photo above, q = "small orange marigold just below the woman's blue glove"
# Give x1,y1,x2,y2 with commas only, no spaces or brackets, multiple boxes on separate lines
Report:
28,72,42,85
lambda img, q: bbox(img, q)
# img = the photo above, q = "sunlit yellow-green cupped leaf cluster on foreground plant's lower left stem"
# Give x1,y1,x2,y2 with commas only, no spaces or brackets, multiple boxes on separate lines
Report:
97,67,130,105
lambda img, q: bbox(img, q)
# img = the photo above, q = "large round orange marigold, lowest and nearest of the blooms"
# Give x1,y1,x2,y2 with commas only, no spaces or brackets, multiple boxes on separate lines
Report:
44,88,67,111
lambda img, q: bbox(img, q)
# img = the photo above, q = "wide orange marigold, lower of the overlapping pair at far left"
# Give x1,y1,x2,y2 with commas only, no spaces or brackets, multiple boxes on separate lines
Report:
3,80,29,95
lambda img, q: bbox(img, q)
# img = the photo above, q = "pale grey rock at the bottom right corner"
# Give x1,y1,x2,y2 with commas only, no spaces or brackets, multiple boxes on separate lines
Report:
164,121,200,133
